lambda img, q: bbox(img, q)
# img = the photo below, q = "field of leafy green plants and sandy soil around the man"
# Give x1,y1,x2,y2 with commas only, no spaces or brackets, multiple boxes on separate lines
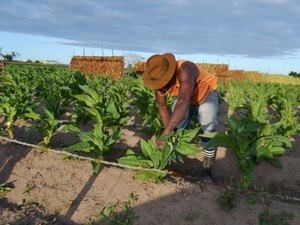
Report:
0,64,300,225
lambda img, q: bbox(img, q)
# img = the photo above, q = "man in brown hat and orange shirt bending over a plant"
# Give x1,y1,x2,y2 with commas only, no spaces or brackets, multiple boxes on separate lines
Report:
143,53,219,182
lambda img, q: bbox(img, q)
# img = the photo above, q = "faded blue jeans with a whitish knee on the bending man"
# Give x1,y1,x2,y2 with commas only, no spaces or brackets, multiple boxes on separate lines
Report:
172,90,219,148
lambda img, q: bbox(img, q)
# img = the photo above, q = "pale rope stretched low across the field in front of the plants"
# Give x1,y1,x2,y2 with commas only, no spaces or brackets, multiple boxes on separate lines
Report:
0,136,172,174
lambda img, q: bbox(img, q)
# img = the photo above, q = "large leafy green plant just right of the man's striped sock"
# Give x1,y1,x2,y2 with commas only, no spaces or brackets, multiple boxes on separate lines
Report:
201,100,292,189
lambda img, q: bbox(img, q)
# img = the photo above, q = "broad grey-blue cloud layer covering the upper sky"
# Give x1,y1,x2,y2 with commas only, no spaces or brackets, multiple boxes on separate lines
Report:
0,0,300,57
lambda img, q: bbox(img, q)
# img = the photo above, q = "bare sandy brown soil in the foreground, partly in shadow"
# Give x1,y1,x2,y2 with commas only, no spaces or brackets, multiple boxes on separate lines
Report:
0,101,300,225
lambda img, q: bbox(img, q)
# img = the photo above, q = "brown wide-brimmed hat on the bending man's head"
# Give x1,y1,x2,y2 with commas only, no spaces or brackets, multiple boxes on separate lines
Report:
143,53,176,90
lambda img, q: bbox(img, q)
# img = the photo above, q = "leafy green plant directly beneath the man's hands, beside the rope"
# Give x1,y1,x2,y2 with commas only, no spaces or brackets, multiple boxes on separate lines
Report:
118,127,200,181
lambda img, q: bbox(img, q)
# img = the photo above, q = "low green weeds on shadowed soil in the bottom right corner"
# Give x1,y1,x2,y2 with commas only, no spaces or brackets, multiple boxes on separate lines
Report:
258,209,295,225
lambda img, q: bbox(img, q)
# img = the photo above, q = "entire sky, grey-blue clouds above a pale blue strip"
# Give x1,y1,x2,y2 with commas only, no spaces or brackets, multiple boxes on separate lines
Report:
0,0,300,74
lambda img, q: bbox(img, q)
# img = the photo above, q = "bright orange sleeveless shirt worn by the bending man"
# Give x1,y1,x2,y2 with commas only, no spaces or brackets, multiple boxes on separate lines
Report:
169,60,218,105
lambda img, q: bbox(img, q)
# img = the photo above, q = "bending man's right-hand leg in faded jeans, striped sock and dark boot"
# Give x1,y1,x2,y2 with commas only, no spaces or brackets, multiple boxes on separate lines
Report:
198,91,219,181
